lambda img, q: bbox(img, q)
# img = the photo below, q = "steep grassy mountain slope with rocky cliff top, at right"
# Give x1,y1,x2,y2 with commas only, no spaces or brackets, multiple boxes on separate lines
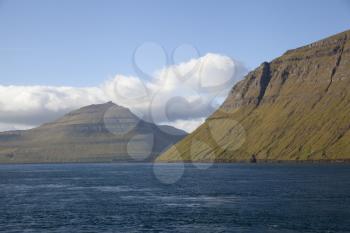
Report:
157,31,350,162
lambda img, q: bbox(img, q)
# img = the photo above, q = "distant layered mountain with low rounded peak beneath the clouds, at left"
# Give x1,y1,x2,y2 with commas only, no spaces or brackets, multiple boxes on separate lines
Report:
0,102,186,163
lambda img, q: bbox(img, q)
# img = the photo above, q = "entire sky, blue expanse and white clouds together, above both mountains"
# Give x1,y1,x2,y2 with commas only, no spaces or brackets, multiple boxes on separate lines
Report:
0,0,350,131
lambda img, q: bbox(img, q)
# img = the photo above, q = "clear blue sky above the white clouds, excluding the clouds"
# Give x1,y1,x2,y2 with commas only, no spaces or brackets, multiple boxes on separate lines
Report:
0,0,350,87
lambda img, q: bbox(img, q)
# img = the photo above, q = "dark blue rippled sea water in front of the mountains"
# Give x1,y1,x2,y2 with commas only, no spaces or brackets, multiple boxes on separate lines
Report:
0,164,350,233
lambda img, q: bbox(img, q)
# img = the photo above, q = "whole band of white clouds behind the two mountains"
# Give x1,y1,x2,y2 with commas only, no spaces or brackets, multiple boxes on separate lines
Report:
0,54,246,131
